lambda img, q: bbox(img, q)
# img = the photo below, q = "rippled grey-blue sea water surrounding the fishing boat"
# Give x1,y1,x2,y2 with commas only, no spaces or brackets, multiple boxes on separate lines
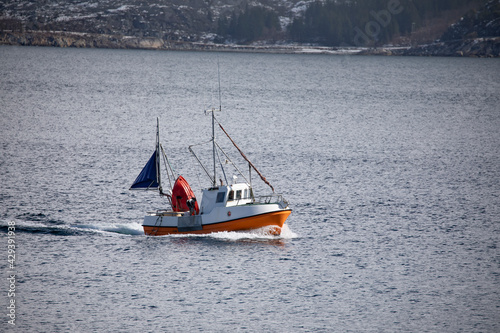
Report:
0,46,500,332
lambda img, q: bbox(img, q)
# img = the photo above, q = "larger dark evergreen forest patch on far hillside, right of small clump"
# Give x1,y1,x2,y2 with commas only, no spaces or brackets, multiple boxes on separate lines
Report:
288,0,485,46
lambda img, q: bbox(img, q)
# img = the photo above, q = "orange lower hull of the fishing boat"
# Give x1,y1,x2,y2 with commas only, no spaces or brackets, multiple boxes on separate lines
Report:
143,209,292,236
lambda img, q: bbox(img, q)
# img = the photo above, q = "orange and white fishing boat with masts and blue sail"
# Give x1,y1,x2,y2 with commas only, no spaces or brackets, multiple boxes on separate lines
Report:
130,109,292,236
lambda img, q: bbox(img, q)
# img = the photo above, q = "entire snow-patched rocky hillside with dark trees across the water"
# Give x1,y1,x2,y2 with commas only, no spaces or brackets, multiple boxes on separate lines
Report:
0,0,500,55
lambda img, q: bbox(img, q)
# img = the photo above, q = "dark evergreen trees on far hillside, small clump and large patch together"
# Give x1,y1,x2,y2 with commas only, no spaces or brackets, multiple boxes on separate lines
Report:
217,0,486,46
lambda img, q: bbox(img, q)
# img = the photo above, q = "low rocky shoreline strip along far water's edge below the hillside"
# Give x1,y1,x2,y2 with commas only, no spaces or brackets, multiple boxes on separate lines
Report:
0,31,500,58
